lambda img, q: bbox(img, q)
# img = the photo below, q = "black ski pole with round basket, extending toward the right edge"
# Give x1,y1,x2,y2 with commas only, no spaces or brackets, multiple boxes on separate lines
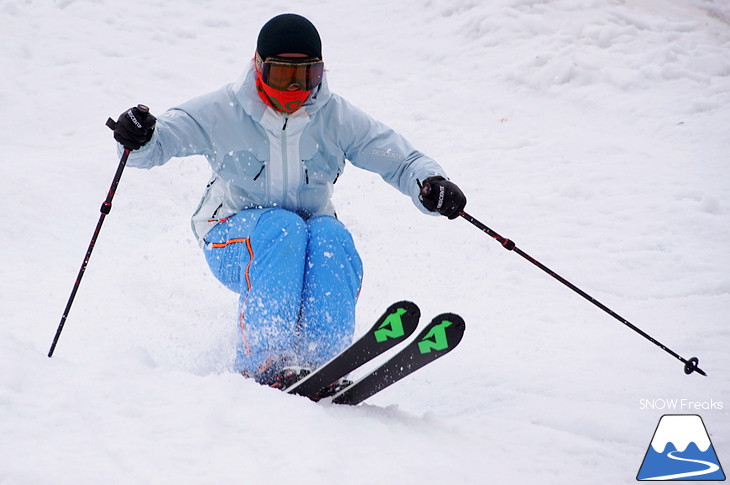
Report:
459,211,707,376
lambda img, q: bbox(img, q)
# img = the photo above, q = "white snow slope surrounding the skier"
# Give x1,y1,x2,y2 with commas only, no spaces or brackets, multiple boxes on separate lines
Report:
0,0,730,485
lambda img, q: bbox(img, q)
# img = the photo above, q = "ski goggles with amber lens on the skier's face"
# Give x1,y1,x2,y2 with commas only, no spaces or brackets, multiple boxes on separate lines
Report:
256,53,324,91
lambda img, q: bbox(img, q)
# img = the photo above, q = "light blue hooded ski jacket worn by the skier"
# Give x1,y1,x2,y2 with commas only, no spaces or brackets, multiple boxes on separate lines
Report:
120,63,446,244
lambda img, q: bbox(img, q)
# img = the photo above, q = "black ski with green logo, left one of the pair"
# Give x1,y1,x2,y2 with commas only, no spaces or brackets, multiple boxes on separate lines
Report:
286,301,421,400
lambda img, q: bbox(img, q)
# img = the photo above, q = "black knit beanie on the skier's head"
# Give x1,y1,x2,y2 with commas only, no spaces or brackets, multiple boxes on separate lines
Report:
256,13,322,60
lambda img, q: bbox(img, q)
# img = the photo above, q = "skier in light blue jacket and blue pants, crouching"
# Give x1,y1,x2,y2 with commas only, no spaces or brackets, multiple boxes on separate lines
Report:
114,13,466,387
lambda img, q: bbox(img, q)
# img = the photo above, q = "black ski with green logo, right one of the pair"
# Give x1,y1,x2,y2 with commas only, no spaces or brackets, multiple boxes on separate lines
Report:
332,313,466,405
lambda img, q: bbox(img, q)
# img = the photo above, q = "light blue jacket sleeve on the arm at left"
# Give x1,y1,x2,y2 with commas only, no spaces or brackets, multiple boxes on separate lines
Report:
117,97,213,168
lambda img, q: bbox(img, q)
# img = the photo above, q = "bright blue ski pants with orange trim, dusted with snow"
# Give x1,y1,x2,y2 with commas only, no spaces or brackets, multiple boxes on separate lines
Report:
204,208,363,374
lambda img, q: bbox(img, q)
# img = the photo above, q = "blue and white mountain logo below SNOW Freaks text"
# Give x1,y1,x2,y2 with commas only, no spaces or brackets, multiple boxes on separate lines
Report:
636,414,725,481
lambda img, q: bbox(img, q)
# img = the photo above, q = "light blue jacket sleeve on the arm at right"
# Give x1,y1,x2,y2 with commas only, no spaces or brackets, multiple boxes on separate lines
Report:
333,97,448,215
